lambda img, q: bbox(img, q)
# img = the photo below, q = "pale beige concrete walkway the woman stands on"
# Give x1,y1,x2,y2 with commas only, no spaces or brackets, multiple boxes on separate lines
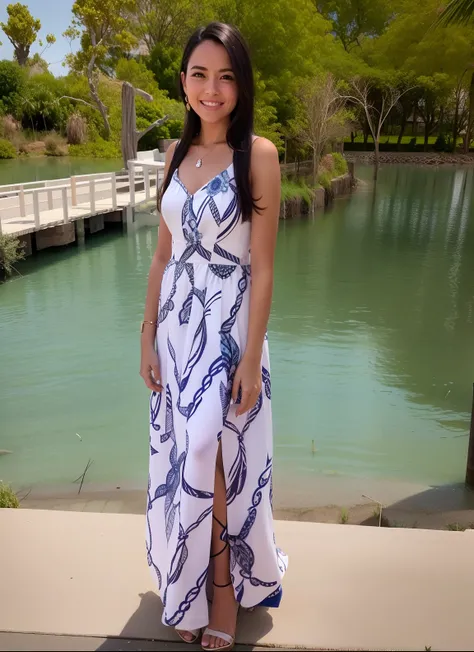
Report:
0,509,474,650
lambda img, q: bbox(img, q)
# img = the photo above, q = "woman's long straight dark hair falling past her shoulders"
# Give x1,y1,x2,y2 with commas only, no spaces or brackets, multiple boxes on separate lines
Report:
158,23,258,221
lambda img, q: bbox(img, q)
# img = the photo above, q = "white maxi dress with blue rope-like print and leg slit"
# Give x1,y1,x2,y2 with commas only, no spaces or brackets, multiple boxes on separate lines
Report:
146,158,287,630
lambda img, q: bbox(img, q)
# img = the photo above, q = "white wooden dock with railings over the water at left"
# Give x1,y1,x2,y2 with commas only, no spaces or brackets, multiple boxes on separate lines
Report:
0,160,164,253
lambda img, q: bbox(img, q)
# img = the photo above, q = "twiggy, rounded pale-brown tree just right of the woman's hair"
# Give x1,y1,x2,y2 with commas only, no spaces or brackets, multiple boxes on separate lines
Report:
292,73,349,185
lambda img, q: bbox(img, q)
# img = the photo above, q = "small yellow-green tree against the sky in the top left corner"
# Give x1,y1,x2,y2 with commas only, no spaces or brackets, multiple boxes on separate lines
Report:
0,2,56,66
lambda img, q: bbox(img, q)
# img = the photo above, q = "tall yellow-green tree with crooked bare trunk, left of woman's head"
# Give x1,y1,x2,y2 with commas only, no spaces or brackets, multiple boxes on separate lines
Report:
65,0,135,139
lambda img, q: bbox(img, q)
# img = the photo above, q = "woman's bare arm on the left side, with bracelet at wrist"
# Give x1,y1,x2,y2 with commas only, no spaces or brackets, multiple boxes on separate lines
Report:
140,143,175,392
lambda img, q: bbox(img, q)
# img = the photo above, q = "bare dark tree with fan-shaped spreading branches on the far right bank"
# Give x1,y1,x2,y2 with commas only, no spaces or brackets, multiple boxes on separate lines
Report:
342,77,411,181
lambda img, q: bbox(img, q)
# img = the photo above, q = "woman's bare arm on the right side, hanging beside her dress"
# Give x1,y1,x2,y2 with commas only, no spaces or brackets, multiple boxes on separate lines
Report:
232,138,281,416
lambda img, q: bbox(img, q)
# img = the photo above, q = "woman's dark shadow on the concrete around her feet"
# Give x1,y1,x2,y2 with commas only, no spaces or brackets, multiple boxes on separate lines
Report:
96,591,273,652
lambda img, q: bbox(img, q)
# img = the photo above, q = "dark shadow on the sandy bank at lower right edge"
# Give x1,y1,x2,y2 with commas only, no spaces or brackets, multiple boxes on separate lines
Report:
361,483,474,527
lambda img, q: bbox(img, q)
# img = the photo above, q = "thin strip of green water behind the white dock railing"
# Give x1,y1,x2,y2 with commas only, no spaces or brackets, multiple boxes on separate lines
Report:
0,156,123,186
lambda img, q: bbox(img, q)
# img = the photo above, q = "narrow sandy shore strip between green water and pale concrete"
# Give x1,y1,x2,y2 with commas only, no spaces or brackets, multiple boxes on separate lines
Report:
18,478,474,530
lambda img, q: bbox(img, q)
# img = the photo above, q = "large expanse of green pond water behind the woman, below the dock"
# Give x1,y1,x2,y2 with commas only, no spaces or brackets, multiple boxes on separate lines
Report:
0,166,474,494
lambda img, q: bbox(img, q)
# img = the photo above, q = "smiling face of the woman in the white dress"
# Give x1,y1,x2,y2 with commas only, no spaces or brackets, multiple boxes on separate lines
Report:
181,41,238,123
